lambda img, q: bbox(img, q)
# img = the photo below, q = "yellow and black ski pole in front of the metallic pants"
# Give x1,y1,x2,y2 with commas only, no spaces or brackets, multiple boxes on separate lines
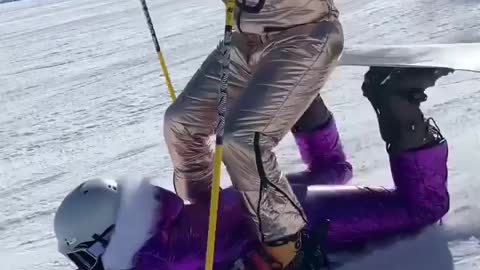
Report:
205,0,235,270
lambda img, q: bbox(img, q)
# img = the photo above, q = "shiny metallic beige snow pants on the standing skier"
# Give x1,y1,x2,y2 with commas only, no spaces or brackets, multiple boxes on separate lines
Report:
164,19,344,242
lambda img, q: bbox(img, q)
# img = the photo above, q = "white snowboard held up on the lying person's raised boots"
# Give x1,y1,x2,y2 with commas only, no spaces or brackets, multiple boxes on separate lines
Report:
339,43,480,73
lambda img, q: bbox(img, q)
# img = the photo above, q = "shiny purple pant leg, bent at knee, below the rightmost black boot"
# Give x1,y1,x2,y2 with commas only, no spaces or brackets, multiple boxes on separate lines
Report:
294,142,449,251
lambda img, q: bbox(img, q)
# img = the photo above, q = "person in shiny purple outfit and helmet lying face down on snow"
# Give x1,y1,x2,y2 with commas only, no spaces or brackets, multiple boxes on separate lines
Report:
54,67,450,270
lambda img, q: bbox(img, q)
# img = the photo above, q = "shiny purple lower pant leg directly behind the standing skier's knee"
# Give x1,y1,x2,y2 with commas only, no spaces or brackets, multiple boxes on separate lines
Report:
287,117,352,185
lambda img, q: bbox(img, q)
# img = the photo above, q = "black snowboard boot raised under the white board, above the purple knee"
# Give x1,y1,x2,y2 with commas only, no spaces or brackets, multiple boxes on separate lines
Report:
362,67,453,155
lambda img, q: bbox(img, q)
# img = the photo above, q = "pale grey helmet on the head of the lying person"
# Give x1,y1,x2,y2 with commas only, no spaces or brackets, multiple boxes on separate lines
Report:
54,179,120,270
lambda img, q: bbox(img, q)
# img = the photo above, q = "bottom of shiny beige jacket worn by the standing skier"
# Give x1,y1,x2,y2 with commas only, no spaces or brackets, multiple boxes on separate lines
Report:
227,0,339,34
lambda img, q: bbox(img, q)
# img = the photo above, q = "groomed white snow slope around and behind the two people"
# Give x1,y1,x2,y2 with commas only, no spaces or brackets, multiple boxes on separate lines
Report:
0,0,480,270
